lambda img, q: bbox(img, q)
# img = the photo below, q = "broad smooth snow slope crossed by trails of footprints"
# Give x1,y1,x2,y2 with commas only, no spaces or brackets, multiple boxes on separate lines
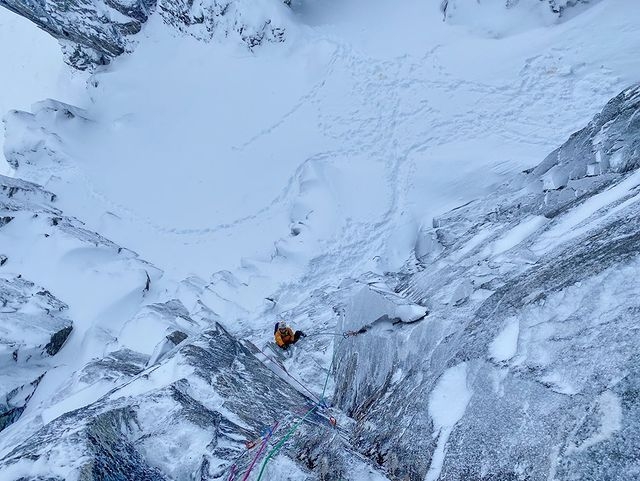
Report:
8,1,638,294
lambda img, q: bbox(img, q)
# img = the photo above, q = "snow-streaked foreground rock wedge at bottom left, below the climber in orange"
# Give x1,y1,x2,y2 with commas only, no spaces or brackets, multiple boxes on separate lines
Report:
0,325,381,481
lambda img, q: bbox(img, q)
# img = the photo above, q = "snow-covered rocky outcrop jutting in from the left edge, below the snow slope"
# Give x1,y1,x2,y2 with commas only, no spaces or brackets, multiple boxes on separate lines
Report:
0,169,162,436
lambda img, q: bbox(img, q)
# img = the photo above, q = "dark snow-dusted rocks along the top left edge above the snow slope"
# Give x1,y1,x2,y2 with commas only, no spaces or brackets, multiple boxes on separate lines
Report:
0,0,289,70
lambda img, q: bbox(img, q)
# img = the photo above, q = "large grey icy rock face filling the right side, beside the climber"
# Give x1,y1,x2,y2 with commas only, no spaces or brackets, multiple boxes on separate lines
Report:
336,87,640,481
